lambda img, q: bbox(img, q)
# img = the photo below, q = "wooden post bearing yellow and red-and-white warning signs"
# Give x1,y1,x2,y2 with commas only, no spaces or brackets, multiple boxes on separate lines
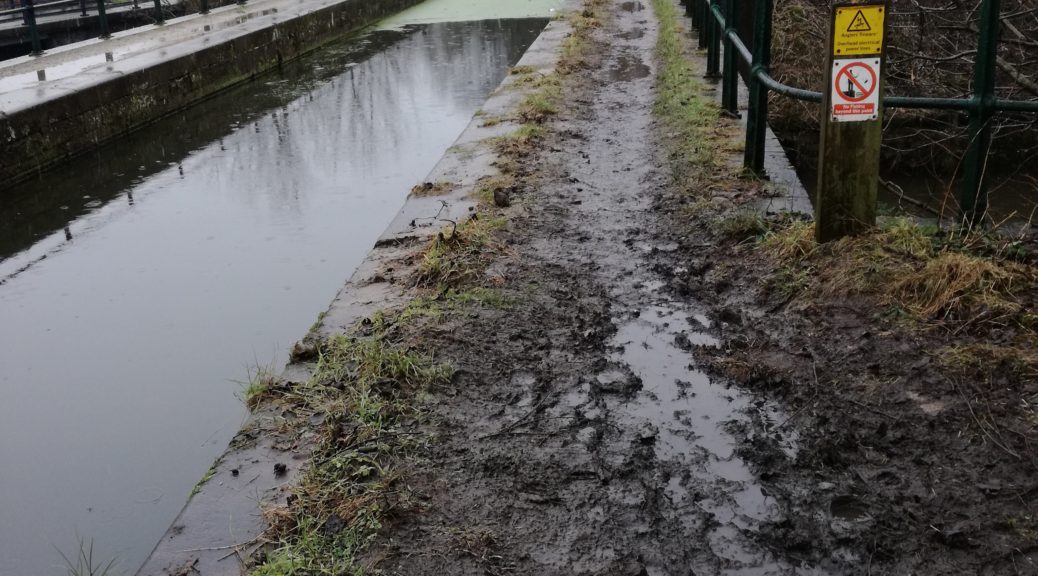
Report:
815,3,886,242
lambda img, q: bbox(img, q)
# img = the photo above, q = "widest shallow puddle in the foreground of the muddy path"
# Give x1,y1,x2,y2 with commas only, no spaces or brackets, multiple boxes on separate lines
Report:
600,294,807,574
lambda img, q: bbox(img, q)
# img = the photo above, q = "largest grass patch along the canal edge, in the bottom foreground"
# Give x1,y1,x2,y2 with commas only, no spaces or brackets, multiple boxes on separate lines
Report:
252,334,454,576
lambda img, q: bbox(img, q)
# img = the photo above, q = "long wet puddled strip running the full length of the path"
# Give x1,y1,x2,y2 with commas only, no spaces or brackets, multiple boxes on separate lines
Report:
568,2,821,575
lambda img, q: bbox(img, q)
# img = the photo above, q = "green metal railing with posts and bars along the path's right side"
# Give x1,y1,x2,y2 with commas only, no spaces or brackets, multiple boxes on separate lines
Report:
681,0,1038,224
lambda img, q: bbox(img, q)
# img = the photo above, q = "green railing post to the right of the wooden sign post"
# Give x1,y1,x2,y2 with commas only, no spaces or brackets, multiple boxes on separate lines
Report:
959,0,1000,227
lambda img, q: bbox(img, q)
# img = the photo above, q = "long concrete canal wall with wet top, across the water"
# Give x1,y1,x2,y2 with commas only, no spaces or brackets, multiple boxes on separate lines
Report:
0,0,421,189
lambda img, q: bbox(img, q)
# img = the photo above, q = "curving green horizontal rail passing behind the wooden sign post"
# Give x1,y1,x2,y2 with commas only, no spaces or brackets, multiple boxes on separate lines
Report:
710,2,1038,112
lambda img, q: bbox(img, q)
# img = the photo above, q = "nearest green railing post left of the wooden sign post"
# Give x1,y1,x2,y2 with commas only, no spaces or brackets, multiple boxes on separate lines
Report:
743,0,772,175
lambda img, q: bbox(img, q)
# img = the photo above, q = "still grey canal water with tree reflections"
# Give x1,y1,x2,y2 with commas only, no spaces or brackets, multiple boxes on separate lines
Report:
0,14,546,576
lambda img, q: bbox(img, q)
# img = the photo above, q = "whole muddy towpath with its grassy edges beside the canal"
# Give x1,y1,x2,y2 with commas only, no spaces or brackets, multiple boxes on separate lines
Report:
231,0,1038,576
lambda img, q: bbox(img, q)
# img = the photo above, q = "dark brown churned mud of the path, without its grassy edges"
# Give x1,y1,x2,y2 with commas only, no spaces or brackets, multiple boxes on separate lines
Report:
359,1,1038,576
